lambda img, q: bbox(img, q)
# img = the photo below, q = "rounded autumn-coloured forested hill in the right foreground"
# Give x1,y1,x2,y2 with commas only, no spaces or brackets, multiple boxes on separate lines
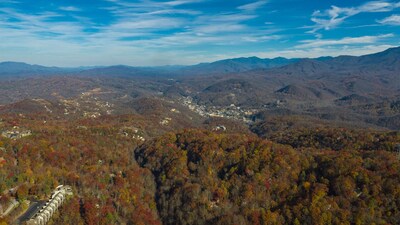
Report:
136,130,400,224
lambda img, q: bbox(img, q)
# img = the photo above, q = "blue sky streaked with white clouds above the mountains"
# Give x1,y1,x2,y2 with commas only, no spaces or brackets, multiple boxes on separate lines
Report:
0,0,400,66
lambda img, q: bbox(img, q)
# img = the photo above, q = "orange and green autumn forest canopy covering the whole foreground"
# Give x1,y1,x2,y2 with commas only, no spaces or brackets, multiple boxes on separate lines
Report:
0,111,400,224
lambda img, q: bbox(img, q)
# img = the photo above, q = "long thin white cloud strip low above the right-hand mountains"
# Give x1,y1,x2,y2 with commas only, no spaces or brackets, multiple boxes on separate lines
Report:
296,34,394,48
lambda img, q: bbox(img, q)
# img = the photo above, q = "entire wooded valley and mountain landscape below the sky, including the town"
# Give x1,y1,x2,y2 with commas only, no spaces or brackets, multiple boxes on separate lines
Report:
0,48,400,224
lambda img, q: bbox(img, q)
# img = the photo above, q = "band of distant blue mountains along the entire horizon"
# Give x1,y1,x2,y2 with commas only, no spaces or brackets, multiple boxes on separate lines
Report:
0,47,400,76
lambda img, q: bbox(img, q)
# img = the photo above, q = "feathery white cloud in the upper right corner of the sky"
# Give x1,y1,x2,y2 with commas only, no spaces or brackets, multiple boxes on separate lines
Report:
311,1,400,33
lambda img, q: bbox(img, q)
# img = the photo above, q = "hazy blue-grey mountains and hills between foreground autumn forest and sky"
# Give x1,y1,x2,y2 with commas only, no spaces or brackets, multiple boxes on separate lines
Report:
0,47,400,129
